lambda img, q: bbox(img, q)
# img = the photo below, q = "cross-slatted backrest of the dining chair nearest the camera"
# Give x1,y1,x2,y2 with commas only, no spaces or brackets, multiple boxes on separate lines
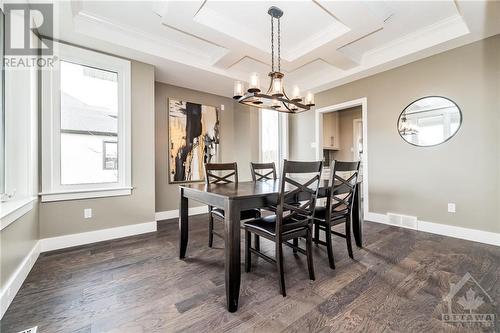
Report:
276,160,323,235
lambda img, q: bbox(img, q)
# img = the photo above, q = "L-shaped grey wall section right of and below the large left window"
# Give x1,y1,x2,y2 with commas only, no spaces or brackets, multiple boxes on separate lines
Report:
40,61,155,238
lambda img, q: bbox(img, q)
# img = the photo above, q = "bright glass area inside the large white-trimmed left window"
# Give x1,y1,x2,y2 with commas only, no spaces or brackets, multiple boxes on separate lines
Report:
61,61,118,185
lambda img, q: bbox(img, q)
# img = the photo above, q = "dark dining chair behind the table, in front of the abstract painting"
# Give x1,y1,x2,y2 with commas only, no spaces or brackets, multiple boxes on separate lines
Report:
205,162,261,247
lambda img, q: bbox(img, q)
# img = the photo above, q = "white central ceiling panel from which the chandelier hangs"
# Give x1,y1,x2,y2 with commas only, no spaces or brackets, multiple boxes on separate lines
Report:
194,0,350,61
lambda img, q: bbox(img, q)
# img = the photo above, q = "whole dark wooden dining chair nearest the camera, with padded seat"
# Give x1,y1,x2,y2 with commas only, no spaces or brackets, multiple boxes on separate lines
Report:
244,160,322,297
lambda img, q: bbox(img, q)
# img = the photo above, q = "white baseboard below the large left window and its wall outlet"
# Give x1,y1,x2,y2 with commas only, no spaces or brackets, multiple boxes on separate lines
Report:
40,221,157,252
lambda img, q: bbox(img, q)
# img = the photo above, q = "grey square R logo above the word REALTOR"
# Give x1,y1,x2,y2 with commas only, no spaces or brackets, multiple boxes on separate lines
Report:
4,3,53,56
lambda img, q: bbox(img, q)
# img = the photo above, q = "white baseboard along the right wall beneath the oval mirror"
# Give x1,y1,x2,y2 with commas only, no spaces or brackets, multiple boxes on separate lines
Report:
364,212,500,246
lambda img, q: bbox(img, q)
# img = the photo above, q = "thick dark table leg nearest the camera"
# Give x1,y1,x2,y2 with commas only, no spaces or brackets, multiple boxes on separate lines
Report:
224,199,241,312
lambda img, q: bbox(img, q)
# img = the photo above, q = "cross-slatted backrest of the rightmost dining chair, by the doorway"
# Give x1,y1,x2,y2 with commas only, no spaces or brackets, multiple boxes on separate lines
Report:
326,161,360,214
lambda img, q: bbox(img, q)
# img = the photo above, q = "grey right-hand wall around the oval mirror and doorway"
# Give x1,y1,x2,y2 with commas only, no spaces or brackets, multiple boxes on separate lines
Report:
290,35,500,232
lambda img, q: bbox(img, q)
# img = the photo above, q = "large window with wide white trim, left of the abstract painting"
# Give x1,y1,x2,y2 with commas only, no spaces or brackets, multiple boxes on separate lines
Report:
42,44,131,201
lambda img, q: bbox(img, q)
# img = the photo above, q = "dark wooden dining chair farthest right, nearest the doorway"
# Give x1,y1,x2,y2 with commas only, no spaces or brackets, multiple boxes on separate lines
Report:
314,161,360,269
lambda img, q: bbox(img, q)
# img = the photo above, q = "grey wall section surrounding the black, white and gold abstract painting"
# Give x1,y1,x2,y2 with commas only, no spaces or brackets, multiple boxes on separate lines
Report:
155,82,259,212
